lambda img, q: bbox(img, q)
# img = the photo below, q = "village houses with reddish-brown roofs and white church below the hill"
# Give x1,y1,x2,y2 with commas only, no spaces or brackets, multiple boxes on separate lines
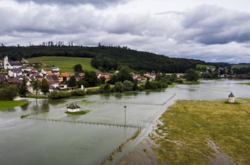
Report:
0,56,183,94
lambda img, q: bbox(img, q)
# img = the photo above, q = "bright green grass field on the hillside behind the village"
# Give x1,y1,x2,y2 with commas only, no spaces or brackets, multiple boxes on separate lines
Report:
27,56,99,72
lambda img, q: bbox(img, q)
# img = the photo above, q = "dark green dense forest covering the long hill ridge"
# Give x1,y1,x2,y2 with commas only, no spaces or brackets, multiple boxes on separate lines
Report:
0,44,205,73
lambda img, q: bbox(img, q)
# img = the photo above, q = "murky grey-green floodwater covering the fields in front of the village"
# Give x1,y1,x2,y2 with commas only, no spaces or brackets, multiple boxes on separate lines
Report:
0,79,250,165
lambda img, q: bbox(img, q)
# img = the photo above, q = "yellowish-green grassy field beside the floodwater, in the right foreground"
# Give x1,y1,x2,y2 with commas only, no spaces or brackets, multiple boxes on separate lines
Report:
149,98,250,165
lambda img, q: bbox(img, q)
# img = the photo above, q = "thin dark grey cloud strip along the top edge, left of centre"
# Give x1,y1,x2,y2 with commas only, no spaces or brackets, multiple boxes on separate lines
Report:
12,0,126,8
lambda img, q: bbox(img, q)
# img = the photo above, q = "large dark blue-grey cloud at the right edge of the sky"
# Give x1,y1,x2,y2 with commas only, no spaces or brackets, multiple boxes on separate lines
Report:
175,5,250,45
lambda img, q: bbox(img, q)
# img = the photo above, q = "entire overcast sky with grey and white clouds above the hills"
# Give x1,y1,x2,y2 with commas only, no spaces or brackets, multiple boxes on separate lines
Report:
0,0,250,63
